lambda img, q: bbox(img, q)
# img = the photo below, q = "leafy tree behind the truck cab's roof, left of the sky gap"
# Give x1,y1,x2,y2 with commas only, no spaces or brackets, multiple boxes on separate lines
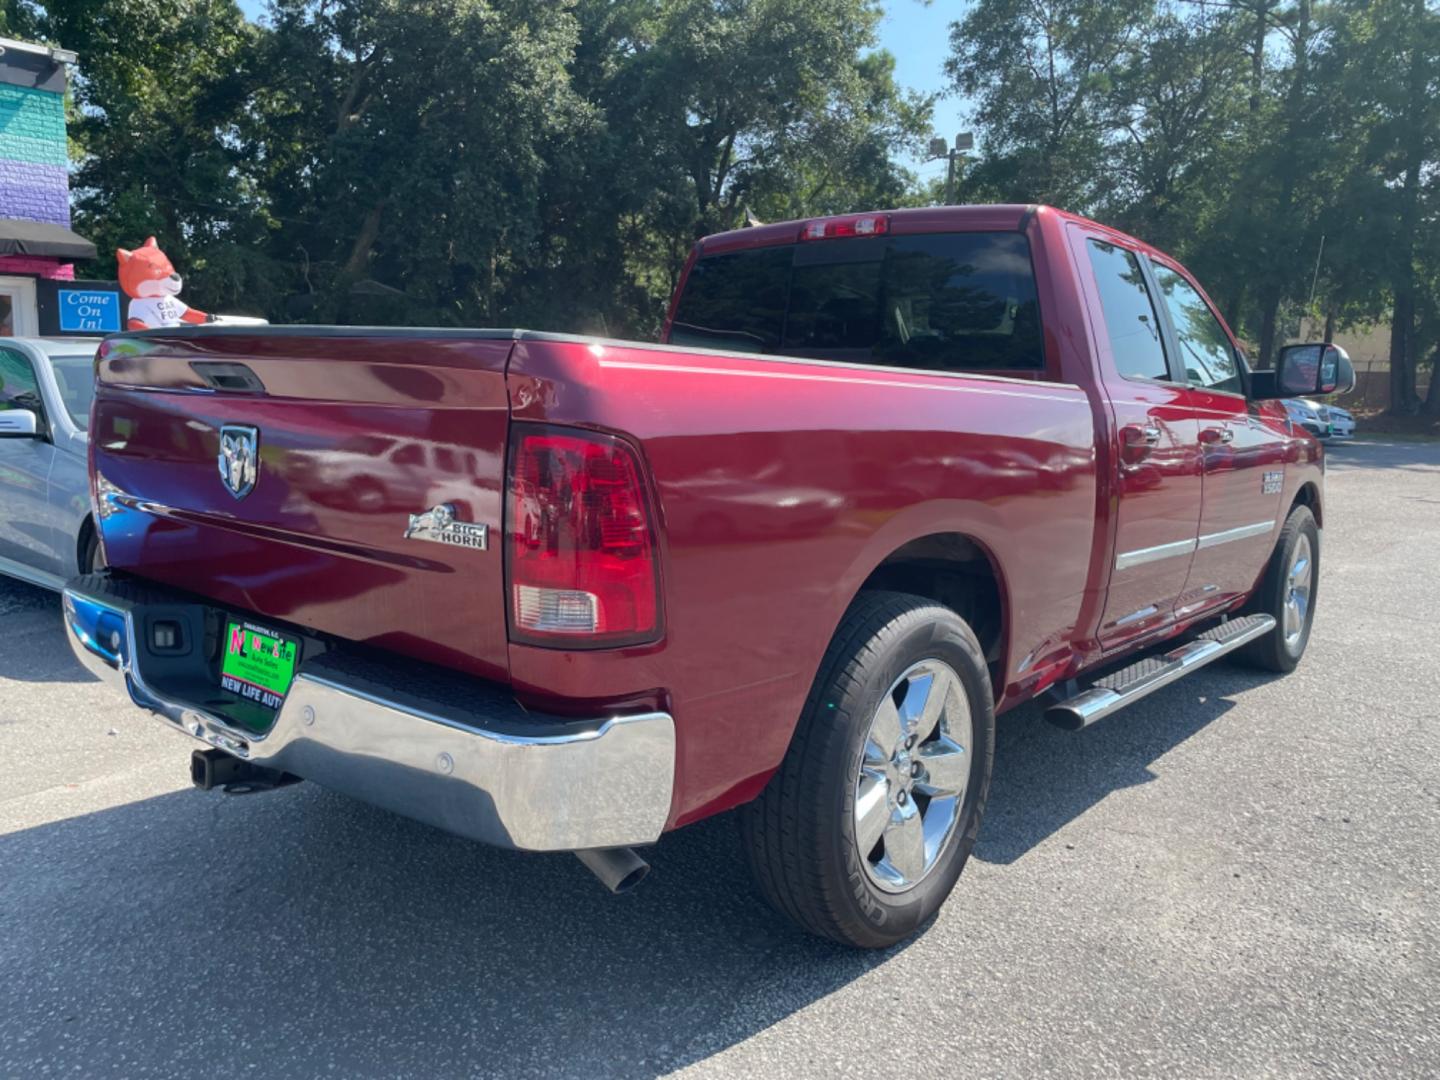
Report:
549,0,930,333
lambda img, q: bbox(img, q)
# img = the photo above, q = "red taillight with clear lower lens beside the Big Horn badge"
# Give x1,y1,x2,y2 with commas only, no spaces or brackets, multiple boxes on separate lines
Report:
505,423,661,648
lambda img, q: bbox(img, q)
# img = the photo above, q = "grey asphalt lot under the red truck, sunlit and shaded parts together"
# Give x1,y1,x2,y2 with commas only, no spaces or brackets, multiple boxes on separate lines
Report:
0,444,1440,1077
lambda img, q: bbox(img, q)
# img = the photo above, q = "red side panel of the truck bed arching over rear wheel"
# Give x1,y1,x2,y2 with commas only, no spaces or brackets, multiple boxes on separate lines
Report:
507,337,1096,824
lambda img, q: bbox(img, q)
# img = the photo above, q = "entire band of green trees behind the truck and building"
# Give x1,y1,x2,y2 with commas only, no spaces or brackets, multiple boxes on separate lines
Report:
22,0,1440,410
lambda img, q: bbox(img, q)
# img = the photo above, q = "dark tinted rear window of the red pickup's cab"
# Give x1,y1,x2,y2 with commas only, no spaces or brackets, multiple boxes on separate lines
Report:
670,232,1044,372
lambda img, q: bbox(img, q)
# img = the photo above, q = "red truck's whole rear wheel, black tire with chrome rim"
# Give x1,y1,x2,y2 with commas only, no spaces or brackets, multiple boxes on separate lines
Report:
740,592,995,949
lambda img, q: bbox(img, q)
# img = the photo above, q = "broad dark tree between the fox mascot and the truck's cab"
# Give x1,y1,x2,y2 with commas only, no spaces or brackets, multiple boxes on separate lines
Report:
242,0,583,324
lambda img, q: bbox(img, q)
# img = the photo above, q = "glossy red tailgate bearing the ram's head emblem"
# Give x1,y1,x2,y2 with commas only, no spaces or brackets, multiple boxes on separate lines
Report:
91,327,513,678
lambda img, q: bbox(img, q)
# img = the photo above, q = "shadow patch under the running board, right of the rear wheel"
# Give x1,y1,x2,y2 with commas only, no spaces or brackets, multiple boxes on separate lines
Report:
975,662,1273,864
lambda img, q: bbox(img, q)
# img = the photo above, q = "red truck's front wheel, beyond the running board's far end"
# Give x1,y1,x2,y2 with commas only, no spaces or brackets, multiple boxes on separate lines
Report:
1238,507,1320,674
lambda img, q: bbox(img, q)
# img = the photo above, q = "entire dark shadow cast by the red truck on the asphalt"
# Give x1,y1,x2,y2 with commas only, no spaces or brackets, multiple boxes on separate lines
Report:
0,668,1260,1077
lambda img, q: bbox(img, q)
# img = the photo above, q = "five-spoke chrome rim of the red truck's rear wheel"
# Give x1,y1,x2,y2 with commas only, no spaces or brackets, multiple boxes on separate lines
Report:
854,660,972,893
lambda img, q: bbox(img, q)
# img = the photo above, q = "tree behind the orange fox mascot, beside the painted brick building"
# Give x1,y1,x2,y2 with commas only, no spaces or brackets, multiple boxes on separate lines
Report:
39,0,271,310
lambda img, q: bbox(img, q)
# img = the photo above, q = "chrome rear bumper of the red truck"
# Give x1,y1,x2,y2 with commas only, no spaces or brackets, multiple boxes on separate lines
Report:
65,575,675,851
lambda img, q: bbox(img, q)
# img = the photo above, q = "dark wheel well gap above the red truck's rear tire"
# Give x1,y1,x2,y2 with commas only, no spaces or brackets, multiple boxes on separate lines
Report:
860,533,1005,687
